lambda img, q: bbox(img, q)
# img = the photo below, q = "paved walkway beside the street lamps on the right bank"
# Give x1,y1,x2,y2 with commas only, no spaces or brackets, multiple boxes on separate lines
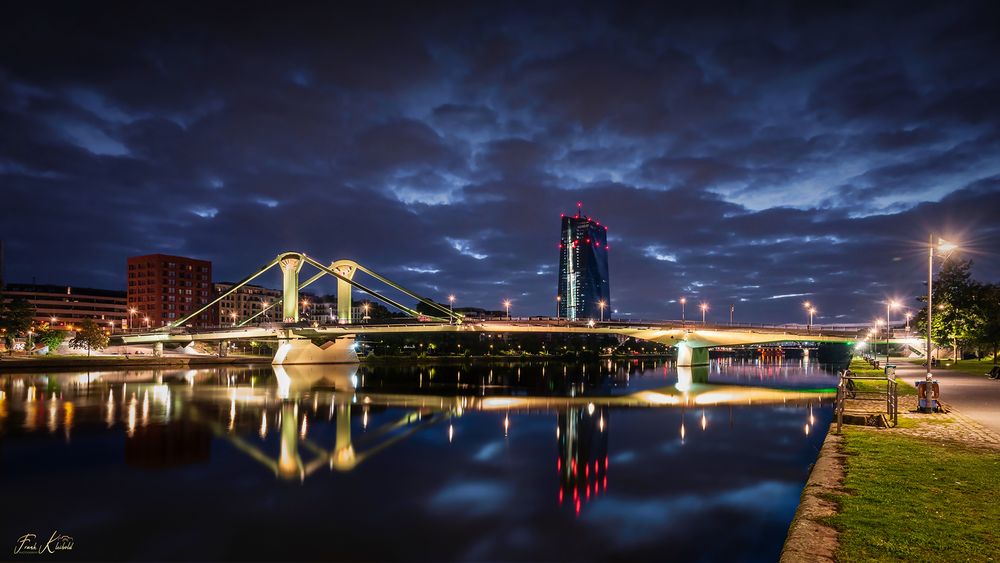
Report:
892,358,1000,434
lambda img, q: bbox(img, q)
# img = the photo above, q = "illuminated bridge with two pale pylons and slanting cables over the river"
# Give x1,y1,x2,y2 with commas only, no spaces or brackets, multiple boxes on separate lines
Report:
122,252,909,366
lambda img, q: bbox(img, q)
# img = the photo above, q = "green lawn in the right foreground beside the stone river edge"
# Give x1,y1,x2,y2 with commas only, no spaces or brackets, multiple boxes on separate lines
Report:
827,428,1000,561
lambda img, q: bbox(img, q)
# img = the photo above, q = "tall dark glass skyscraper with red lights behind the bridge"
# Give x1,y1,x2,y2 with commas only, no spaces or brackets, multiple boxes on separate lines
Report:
556,203,611,320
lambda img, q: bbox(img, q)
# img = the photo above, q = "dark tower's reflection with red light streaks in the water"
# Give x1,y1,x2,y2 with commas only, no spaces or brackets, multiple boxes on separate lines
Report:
556,403,609,515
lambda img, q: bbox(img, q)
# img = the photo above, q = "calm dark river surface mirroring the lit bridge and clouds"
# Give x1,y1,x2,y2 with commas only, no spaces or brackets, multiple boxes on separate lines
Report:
0,360,835,561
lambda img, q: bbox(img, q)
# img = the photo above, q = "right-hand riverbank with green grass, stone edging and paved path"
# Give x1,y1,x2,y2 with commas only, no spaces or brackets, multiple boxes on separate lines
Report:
782,354,1000,561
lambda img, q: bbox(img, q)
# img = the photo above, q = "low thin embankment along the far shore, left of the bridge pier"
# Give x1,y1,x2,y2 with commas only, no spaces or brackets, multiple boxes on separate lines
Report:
0,356,271,373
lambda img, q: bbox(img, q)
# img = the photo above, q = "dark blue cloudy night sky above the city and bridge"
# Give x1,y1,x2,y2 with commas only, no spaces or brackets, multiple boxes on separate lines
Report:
0,2,1000,323
